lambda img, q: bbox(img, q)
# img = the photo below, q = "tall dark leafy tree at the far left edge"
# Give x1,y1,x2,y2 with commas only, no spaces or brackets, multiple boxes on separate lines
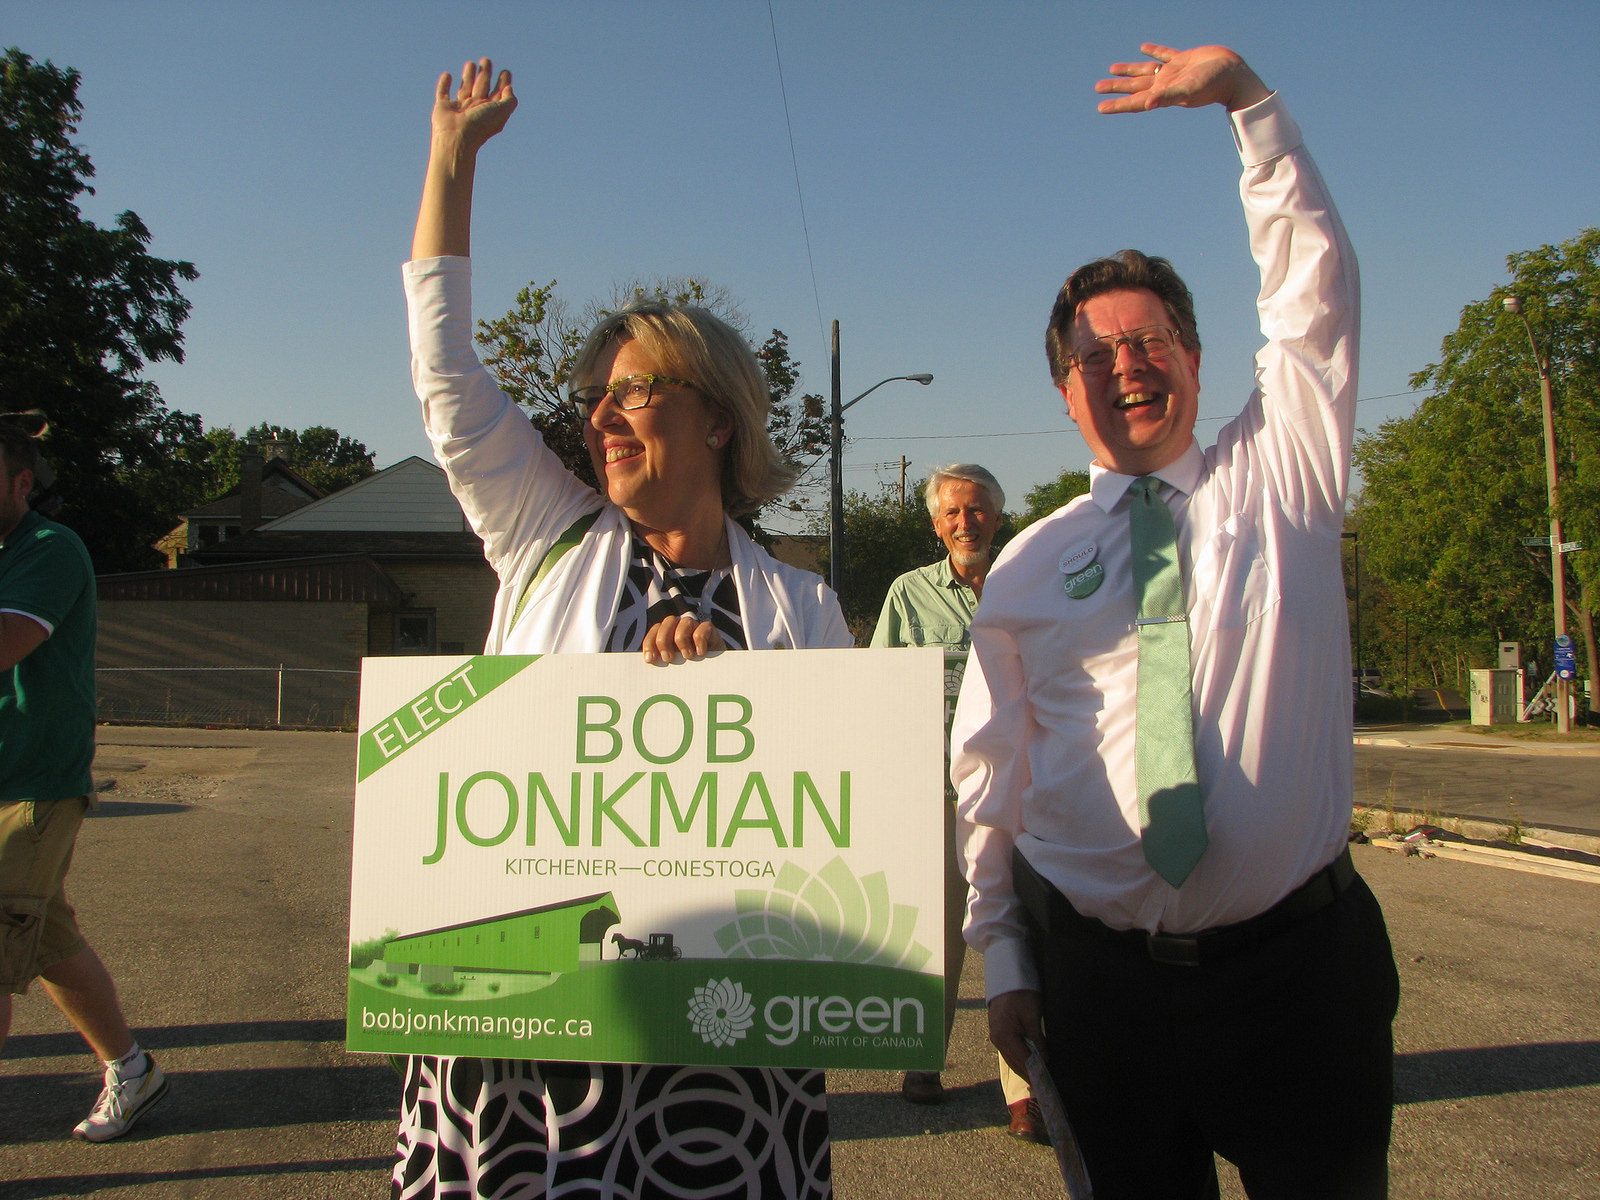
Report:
0,46,206,571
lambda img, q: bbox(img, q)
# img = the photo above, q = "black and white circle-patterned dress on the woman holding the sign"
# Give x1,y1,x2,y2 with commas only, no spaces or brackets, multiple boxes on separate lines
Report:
390,536,834,1200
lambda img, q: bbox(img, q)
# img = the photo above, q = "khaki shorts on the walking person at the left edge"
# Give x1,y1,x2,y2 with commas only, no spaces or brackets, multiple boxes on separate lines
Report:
0,797,88,995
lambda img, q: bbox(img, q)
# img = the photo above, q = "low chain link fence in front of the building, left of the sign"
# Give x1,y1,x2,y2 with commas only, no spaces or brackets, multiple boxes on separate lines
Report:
94,666,362,730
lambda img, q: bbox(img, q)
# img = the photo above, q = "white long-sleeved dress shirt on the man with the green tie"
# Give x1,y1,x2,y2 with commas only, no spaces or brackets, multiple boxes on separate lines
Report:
950,93,1360,997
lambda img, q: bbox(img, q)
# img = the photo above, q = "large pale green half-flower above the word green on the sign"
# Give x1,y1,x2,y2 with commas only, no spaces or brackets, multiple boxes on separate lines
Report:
717,858,933,971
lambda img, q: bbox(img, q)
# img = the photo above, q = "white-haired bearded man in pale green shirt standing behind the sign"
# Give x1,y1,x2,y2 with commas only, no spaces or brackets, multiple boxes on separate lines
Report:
872,462,1042,1141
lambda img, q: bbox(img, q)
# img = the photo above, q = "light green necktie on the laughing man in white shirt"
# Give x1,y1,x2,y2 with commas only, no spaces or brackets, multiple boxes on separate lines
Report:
1128,475,1206,888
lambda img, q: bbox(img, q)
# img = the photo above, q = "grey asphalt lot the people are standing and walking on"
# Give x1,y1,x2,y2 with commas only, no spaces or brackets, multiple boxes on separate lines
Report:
0,728,1600,1200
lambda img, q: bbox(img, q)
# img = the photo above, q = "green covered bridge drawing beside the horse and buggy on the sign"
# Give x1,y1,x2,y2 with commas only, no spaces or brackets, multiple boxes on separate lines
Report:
384,891,621,982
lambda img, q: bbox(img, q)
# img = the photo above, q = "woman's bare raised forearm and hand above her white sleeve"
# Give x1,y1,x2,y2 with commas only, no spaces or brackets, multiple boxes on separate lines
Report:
411,58,517,259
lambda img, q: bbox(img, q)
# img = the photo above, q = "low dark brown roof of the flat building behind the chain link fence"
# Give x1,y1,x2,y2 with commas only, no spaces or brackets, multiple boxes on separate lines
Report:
94,554,406,608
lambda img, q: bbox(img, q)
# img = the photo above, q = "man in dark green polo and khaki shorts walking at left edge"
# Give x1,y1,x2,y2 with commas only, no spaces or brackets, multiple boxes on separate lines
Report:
0,413,166,1142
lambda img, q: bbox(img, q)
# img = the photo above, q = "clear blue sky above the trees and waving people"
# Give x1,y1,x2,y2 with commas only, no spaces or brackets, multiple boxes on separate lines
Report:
0,0,1600,534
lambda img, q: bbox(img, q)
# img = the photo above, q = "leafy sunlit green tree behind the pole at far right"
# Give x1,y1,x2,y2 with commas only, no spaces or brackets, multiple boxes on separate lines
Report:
1354,229,1600,700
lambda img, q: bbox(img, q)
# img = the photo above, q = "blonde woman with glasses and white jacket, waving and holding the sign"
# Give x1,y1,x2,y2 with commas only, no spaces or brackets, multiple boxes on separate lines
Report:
394,59,851,1200
